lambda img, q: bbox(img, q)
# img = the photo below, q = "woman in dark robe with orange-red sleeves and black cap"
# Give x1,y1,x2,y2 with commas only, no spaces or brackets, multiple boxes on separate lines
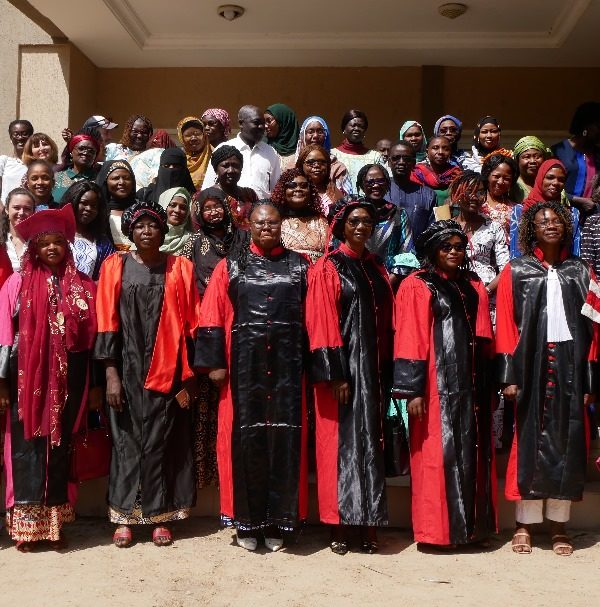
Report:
94,201,199,548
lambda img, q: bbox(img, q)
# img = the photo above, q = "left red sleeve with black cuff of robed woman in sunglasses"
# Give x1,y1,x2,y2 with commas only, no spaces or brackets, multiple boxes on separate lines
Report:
393,274,433,397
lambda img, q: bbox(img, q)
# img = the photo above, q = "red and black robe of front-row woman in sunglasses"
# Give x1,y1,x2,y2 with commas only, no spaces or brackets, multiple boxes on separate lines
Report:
394,271,496,545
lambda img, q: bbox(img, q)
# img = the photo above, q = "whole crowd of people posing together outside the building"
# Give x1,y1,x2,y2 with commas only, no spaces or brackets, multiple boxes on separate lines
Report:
0,102,600,556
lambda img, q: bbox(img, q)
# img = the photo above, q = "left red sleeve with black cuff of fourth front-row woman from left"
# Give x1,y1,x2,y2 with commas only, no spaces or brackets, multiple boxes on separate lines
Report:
306,257,349,383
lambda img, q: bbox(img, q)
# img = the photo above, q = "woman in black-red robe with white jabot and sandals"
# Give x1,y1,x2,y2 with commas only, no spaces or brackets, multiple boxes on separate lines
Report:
496,202,598,556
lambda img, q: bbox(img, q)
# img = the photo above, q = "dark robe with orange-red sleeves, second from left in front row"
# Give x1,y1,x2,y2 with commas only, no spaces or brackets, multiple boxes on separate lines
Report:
94,253,200,517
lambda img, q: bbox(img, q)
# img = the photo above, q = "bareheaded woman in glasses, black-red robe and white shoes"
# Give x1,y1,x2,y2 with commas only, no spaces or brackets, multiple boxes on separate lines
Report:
194,201,309,551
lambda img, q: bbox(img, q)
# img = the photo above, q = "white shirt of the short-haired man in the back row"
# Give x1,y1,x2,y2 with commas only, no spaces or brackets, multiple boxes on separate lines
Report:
203,134,281,199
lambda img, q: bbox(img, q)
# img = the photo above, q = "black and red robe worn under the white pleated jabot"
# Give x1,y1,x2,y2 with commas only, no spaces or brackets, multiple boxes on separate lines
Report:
496,251,598,500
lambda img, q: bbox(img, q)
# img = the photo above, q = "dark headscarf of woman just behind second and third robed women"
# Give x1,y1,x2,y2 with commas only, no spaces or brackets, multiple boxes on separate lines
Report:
192,186,249,295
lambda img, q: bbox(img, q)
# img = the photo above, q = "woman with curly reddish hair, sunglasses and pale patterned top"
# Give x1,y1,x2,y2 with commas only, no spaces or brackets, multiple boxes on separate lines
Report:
271,169,328,262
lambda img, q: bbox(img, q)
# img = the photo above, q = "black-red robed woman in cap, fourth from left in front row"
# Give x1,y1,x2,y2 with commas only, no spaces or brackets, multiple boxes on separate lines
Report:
306,197,394,554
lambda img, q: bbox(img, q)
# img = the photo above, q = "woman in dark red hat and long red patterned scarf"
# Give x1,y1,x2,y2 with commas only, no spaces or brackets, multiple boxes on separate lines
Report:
0,206,97,552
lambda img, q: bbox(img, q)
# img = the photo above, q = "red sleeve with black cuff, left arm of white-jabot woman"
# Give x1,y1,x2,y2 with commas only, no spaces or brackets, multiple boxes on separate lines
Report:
496,263,519,384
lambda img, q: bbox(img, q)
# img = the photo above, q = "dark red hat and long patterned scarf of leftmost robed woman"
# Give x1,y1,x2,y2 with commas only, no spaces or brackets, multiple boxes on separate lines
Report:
16,205,97,446
